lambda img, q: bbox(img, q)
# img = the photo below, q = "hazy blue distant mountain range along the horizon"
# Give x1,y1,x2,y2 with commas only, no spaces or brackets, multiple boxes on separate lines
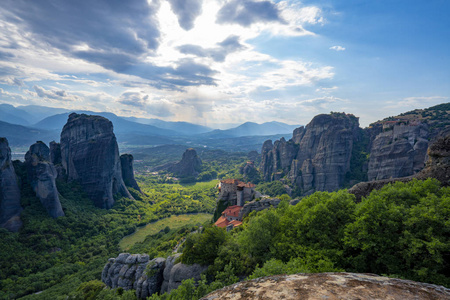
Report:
0,104,299,151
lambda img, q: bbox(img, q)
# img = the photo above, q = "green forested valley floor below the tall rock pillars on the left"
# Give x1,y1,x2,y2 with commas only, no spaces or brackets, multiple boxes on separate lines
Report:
0,167,216,299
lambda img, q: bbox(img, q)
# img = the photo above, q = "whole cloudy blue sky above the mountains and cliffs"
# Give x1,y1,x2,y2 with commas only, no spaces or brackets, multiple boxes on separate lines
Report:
0,0,450,127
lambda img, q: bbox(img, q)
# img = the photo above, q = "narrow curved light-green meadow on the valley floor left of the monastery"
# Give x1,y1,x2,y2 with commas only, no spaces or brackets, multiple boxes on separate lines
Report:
119,213,212,251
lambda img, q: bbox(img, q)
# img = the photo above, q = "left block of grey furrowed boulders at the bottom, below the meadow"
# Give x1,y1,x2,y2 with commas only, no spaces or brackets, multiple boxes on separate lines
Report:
102,253,166,299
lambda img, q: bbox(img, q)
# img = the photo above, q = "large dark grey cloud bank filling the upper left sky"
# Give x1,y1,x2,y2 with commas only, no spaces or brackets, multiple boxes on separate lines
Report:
0,0,220,89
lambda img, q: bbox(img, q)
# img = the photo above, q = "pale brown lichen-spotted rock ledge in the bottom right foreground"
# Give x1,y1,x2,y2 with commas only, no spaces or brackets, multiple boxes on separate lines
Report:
202,273,450,300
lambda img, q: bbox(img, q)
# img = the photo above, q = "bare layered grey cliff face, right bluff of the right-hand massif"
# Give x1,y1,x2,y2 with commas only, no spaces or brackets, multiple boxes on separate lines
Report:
367,124,429,181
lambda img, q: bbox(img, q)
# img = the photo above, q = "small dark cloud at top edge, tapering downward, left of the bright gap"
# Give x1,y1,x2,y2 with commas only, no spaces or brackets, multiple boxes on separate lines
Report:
168,0,203,30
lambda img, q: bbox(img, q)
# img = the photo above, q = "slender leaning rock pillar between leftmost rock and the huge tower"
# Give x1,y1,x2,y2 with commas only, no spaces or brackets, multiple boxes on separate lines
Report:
25,141,64,218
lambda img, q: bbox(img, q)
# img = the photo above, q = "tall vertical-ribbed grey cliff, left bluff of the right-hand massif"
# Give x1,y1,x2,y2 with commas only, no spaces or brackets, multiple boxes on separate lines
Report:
260,113,359,193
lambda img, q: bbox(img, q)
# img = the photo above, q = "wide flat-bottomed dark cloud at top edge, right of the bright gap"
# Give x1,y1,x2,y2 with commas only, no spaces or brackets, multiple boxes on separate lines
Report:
217,0,285,27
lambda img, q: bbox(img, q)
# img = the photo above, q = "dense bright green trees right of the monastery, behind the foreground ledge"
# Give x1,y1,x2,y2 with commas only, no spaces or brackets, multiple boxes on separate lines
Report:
151,179,450,299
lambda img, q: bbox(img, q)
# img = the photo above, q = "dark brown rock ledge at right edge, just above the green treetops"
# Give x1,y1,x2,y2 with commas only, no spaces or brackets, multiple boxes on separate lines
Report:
348,134,450,201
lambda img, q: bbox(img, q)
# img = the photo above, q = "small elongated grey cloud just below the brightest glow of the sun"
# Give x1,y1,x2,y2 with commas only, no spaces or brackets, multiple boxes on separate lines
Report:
178,35,245,62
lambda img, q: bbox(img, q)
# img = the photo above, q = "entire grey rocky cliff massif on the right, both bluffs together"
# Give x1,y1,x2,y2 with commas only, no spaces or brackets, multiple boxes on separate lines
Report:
260,103,450,195
